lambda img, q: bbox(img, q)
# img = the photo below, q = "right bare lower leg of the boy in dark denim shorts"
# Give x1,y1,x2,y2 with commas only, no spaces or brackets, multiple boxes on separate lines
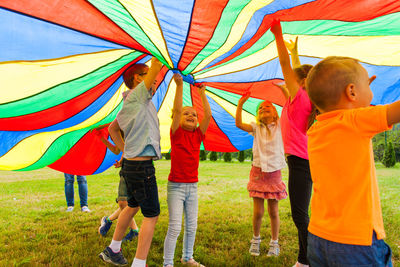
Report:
135,216,158,260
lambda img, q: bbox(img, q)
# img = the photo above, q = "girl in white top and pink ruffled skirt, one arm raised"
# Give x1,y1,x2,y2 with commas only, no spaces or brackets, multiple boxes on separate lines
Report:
236,93,287,256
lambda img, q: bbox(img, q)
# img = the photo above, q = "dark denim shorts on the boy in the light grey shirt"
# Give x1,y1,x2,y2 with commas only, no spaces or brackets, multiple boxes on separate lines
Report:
121,159,160,218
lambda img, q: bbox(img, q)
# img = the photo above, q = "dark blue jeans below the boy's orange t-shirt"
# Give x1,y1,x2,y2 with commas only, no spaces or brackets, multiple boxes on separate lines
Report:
307,232,393,267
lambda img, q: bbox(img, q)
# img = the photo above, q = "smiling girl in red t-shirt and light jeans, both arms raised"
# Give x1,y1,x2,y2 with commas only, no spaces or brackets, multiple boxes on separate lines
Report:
164,74,211,267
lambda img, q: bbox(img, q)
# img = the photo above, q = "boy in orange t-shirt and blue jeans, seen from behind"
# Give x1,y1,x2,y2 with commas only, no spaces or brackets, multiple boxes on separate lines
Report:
306,57,400,267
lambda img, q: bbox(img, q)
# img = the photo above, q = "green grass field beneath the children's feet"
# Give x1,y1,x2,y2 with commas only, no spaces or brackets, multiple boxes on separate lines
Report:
0,160,400,267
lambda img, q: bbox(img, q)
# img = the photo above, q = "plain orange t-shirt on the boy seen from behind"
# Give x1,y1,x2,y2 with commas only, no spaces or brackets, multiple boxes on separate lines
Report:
307,106,390,245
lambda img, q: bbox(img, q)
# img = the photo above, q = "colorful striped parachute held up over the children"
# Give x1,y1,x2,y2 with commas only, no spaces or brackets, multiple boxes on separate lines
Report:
0,0,400,174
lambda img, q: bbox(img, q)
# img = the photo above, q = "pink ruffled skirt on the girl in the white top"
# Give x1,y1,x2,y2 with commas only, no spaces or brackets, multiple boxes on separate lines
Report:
247,166,287,200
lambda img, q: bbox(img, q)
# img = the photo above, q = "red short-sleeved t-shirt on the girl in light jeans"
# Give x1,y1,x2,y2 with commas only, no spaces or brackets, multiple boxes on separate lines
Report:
168,126,205,183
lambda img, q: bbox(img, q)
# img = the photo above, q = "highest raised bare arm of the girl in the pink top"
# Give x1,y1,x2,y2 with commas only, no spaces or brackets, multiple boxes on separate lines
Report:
271,21,300,98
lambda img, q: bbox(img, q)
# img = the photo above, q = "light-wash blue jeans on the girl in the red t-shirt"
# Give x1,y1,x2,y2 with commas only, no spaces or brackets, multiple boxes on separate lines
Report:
164,182,198,265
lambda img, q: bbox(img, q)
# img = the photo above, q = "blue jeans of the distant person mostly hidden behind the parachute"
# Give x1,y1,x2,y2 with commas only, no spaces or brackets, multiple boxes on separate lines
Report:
64,173,88,207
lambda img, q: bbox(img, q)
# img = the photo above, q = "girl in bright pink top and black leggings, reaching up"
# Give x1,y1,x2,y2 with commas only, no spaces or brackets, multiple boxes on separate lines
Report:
271,21,314,267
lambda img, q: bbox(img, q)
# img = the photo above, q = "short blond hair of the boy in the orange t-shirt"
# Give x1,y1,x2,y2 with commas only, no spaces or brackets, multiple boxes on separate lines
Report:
306,57,361,110
